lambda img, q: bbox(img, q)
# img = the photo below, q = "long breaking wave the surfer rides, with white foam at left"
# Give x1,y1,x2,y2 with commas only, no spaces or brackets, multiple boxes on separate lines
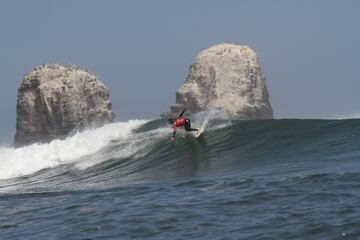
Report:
0,116,360,188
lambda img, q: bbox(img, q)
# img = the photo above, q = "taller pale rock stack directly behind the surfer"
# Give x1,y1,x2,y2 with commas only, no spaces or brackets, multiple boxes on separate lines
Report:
166,44,273,119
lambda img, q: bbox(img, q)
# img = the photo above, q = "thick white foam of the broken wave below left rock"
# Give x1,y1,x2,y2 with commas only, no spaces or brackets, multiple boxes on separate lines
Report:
0,120,147,179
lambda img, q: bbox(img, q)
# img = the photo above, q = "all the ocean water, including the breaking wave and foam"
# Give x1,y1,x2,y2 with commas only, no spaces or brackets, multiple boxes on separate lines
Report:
0,114,360,239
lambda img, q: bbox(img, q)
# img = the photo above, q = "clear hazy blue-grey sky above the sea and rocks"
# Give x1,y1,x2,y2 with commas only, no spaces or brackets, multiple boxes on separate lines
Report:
0,0,360,142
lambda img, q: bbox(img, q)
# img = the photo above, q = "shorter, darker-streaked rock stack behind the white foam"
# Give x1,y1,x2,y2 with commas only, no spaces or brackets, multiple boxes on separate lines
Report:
14,64,115,147
